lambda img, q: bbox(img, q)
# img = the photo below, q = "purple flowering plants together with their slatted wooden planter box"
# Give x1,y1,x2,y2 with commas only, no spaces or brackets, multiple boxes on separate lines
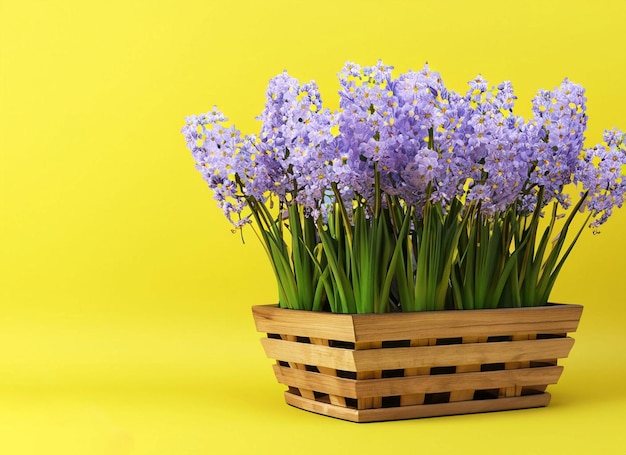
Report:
183,62,626,422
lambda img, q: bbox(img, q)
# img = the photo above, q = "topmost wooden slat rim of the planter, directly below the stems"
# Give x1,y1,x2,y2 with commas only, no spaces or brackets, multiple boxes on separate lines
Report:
252,305,583,342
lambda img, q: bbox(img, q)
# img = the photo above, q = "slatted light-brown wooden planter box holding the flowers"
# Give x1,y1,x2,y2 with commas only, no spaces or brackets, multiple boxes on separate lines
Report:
252,305,583,422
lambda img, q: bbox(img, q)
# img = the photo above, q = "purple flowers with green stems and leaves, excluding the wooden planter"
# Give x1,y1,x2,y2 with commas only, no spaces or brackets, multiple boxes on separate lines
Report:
182,62,626,313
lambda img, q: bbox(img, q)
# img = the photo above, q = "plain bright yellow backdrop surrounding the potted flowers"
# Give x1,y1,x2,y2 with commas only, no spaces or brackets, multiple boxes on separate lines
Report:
0,0,626,455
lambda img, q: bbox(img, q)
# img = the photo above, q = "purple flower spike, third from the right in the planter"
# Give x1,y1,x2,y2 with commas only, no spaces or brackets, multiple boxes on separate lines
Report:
435,75,528,216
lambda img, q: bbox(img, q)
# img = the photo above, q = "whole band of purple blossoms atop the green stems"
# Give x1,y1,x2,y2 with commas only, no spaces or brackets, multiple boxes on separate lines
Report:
183,62,624,225
